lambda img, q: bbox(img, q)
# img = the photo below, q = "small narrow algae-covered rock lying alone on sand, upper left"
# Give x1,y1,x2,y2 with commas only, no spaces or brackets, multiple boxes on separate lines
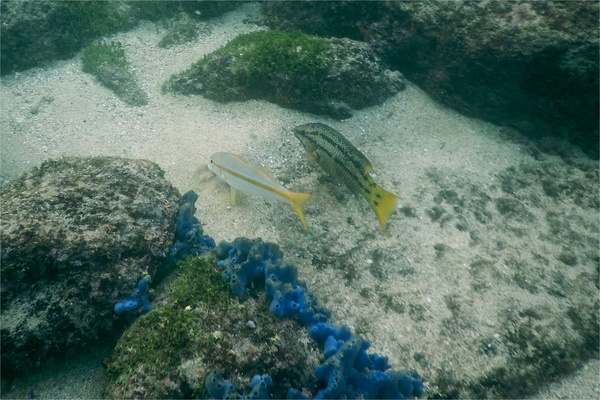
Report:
81,42,148,106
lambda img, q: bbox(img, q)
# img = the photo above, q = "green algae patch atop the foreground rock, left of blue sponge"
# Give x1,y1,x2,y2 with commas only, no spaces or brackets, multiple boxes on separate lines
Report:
105,258,235,397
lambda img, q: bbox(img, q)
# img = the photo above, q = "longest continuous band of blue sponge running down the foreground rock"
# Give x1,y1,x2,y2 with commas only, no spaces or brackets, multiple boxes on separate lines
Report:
215,238,423,399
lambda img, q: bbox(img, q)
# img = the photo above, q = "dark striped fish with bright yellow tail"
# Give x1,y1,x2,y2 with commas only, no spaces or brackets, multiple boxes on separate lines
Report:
293,123,400,232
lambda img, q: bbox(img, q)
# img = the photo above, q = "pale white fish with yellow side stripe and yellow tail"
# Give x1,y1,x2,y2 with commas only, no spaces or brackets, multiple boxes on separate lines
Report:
208,153,310,228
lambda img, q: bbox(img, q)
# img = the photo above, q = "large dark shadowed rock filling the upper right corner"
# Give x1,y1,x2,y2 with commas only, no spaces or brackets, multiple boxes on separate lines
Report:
263,1,600,158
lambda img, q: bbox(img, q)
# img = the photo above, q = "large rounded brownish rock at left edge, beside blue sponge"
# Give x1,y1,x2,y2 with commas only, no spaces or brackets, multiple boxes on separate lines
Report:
0,157,179,377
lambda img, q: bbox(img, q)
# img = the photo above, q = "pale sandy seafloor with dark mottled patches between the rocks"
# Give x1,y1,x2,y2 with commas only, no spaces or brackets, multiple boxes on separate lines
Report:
0,4,599,398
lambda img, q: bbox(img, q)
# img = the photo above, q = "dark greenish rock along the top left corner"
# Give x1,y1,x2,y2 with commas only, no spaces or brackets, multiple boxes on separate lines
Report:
0,0,240,75
